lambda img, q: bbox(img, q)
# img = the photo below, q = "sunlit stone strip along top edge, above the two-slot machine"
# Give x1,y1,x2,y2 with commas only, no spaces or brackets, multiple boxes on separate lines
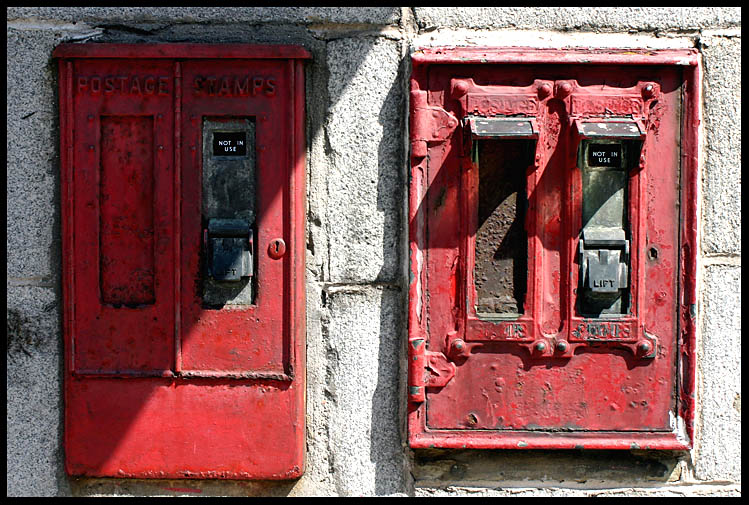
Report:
414,7,741,32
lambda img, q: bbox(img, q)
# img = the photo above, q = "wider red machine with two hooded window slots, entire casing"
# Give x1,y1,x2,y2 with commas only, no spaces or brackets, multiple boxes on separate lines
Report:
409,49,698,449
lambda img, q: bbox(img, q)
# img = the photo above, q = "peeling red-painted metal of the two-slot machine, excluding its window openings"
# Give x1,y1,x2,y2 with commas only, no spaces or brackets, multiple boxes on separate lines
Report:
409,48,699,449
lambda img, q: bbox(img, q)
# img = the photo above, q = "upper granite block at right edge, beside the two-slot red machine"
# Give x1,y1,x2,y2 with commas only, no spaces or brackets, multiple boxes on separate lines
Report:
700,32,741,254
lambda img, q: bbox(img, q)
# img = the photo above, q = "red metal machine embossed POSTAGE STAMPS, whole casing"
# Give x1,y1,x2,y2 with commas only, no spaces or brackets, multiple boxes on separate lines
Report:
54,44,309,479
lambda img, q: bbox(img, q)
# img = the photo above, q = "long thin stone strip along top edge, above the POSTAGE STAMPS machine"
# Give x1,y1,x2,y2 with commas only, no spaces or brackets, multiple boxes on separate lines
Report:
7,7,400,25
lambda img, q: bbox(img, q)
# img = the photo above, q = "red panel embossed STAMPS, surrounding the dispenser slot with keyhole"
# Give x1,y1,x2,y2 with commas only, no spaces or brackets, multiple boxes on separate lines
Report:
181,60,294,377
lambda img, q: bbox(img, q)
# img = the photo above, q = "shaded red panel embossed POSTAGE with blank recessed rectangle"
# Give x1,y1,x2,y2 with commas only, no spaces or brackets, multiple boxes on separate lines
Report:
70,60,174,374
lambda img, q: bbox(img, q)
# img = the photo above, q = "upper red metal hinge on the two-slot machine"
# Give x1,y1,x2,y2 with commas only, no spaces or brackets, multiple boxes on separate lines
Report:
410,90,458,158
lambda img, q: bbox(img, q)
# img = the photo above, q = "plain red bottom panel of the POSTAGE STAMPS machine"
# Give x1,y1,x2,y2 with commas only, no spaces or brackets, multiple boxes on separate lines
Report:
66,378,304,479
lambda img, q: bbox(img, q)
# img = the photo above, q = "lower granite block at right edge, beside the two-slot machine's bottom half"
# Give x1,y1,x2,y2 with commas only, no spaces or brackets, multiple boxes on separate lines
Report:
694,265,741,482
